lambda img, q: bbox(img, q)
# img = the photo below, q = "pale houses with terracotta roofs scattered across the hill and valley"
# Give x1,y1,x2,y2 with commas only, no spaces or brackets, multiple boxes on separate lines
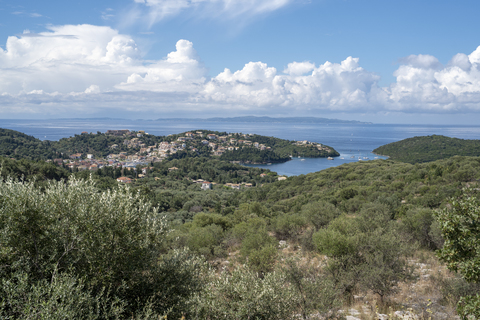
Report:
49,130,322,186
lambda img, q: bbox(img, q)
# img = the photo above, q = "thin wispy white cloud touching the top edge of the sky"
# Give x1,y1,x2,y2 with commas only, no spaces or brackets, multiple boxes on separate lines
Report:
129,0,292,25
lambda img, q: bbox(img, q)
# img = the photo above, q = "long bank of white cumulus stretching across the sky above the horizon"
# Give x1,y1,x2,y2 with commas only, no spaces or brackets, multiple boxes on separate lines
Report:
0,24,480,116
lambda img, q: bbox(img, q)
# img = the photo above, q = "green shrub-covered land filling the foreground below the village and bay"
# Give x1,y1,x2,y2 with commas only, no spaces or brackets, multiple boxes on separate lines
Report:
0,129,480,319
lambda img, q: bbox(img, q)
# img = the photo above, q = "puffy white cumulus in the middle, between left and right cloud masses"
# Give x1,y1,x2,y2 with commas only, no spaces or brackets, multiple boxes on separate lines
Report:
204,57,379,110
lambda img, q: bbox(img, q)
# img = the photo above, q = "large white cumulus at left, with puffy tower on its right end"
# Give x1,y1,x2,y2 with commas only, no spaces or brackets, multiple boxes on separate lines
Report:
0,25,206,94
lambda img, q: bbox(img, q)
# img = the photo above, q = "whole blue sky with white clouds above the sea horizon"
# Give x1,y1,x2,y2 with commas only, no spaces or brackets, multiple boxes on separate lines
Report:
0,0,480,124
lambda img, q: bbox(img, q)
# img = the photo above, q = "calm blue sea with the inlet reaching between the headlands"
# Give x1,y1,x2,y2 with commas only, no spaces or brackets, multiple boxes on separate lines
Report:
0,119,480,176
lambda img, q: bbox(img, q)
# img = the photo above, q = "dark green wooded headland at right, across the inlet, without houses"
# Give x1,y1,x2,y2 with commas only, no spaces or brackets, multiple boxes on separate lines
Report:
373,135,480,163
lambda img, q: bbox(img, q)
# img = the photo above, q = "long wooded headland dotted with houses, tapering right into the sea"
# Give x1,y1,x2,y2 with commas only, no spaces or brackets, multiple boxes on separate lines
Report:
0,129,340,163
